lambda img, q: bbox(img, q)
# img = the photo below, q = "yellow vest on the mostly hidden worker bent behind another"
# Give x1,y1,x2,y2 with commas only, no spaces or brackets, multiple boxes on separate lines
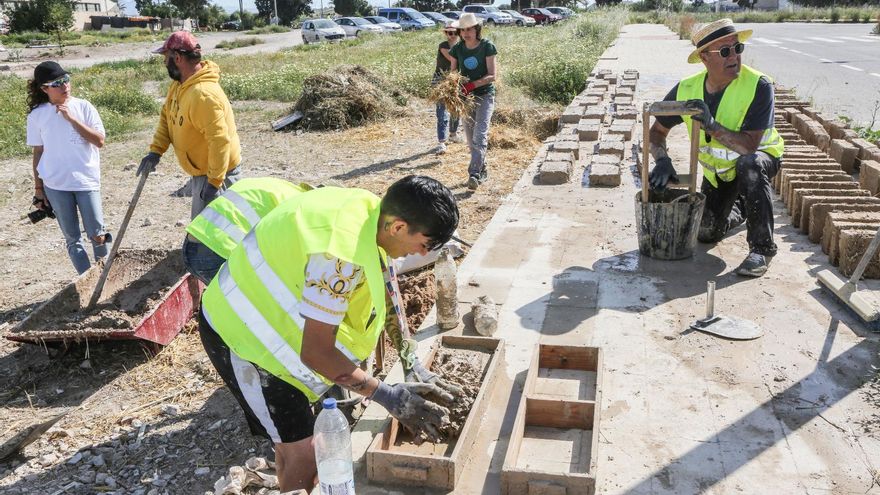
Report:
186,177,312,259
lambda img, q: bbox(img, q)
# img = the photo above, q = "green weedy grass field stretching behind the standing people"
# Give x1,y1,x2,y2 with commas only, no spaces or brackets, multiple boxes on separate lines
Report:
0,9,627,159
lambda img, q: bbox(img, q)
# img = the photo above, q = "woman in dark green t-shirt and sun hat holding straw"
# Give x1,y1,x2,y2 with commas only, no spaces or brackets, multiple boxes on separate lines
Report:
449,12,498,189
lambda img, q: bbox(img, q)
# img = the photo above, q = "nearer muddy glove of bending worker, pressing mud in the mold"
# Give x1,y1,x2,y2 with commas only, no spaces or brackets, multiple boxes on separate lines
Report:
371,382,452,443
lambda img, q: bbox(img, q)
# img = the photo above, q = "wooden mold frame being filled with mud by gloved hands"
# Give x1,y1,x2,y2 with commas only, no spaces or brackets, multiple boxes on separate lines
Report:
367,335,504,490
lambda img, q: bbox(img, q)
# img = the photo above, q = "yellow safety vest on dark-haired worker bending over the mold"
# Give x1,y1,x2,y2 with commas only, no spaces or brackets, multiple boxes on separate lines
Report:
202,187,386,402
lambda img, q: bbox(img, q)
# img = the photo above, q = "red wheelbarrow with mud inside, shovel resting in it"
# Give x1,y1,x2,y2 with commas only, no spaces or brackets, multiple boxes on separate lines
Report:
5,250,204,347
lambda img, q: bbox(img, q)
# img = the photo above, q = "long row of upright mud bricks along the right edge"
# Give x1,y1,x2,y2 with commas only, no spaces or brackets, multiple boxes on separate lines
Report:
773,88,880,278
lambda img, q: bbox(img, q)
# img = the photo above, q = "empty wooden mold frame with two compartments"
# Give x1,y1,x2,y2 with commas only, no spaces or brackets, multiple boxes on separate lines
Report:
501,344,602,495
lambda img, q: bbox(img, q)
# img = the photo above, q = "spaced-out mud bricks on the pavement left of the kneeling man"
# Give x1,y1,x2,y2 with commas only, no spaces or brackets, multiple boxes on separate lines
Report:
535,70,639,187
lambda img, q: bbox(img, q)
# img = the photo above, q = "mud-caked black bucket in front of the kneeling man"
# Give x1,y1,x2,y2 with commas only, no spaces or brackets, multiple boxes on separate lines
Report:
636,189,706,260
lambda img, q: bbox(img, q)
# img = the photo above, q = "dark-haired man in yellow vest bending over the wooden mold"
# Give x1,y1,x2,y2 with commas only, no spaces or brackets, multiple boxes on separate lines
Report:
199,176,460,492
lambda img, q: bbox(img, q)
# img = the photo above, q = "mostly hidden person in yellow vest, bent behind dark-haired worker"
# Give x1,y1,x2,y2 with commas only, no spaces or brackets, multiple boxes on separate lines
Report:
183,177,313,284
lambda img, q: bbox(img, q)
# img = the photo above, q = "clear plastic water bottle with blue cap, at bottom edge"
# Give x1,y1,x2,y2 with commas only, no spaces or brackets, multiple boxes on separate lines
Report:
315,398,354,495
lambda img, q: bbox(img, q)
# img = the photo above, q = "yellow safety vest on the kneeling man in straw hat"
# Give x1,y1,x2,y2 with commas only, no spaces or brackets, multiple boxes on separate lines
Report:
675,65,785,187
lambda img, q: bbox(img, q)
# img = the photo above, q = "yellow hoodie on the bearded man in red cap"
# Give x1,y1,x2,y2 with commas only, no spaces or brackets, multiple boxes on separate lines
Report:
150,60,241,188
